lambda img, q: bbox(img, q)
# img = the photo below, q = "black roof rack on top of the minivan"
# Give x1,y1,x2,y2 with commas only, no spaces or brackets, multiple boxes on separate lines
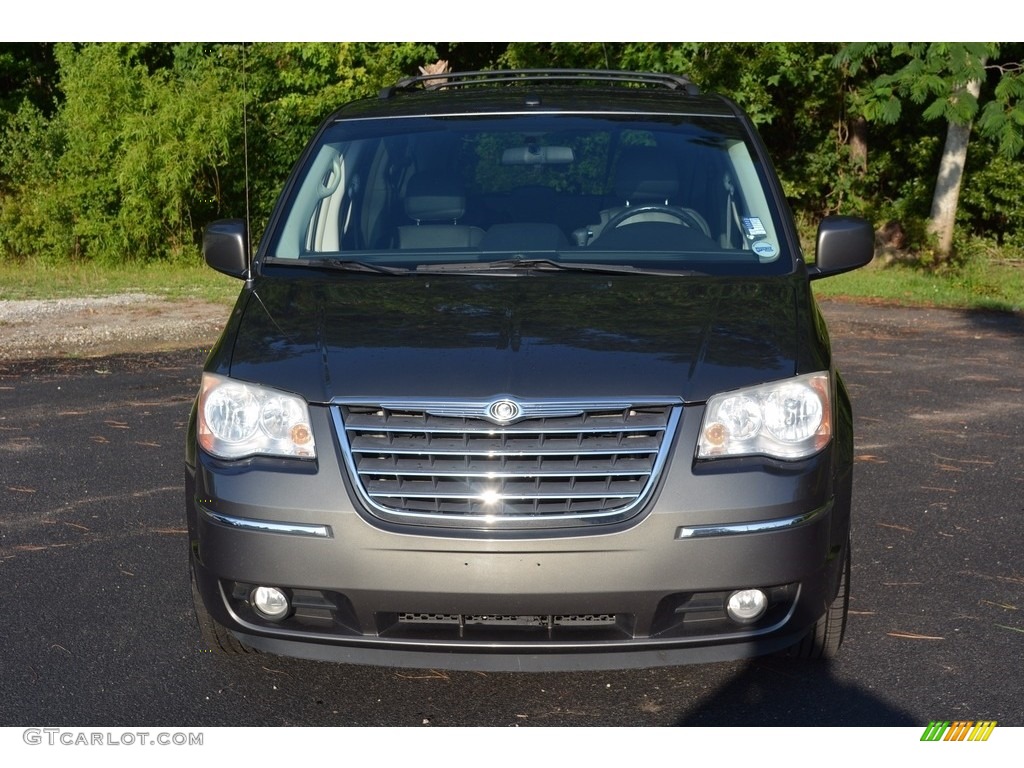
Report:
380,70,700,98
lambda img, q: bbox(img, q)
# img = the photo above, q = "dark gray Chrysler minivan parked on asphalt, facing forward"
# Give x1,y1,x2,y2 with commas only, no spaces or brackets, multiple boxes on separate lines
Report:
185,70,873,670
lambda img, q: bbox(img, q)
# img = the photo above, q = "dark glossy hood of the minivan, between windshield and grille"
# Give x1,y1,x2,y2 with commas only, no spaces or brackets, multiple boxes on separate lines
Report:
224,273,807,402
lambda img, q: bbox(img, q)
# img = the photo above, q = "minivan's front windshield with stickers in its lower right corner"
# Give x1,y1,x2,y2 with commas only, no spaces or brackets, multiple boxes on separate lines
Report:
265,114,792,273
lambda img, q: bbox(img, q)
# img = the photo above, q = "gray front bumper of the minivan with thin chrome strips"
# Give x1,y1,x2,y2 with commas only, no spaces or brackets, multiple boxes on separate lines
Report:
186,405,850,671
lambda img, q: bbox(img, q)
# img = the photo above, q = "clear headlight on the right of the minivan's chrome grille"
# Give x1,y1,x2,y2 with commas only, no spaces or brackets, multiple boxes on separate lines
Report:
697,373,831,459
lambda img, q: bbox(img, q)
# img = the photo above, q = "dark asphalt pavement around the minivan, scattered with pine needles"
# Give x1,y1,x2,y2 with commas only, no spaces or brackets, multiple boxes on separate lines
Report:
0,303,1024,728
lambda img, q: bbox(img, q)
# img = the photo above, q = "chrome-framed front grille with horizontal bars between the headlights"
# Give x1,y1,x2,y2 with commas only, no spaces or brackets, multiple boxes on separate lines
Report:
334,402,681,529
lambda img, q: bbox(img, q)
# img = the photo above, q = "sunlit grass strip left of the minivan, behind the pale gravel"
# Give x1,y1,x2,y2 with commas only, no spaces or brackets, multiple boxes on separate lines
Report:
0,260,242,304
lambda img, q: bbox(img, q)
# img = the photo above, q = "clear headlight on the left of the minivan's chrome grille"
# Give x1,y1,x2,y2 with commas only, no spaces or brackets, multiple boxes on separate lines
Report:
199,374,316,459
